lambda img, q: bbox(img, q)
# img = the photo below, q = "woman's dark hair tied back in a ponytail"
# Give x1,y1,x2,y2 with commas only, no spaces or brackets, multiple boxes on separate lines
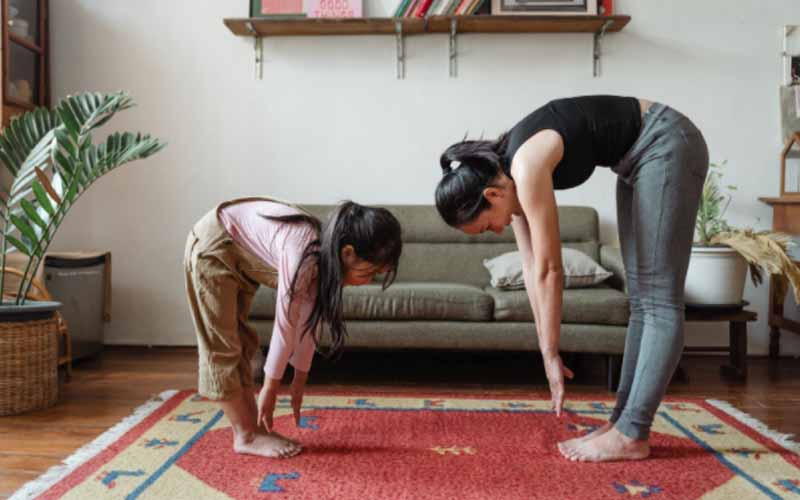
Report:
436,134,508,227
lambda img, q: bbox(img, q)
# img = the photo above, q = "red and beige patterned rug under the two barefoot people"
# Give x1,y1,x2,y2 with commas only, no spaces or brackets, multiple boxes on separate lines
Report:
12,391,800,500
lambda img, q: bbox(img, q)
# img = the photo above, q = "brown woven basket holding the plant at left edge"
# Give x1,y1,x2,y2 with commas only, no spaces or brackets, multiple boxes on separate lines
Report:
0,316,59,415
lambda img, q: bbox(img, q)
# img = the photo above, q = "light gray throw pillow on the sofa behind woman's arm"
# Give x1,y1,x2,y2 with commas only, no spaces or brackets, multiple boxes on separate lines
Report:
483,248,613,290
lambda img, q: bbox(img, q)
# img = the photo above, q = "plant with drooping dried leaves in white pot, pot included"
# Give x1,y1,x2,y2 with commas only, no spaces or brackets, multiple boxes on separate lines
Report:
684,162,800,307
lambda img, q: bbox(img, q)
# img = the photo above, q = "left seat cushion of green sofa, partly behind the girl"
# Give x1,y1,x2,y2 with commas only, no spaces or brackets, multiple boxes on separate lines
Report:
250,283,494,321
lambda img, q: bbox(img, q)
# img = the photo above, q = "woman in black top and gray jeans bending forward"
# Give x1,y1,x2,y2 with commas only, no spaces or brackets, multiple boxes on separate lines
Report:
436,96,708,461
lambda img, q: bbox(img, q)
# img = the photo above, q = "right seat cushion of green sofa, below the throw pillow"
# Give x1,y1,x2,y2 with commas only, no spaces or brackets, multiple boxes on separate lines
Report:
486,284,628,325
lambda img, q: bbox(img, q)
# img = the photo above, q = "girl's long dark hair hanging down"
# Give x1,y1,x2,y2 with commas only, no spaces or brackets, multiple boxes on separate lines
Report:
264,201,403,357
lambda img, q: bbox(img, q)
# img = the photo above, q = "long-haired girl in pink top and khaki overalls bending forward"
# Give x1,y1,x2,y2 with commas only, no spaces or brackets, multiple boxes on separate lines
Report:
184,198,402,457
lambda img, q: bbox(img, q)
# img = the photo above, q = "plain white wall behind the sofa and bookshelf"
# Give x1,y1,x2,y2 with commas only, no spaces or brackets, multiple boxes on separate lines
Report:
51,0,800,354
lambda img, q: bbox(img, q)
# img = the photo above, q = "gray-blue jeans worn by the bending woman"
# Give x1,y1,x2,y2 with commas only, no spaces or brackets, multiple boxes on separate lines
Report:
611,103,708,439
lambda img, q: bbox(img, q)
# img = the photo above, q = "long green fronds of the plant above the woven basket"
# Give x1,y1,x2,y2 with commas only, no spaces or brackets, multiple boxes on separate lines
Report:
0,92,164,305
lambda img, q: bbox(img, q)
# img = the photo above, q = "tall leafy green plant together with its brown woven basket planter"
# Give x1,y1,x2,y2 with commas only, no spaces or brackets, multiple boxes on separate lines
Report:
0,92,165,415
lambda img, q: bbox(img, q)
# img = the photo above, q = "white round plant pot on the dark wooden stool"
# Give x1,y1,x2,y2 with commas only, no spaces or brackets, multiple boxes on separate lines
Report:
684,246,747,306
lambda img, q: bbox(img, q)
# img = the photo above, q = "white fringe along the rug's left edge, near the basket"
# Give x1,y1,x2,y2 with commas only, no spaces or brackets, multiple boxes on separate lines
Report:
9,390,178,500
